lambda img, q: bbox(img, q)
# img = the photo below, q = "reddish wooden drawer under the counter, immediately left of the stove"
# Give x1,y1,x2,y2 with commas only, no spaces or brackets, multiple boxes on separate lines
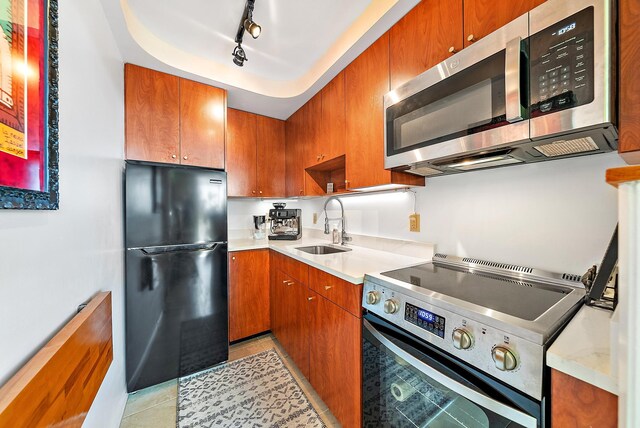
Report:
309,268,362,318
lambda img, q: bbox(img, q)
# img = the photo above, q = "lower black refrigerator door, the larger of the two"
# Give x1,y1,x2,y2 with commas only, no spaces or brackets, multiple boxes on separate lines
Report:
126,243,229,392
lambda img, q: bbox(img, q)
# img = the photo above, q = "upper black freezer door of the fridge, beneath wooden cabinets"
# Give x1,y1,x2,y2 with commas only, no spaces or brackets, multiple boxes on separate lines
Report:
125,162,227,248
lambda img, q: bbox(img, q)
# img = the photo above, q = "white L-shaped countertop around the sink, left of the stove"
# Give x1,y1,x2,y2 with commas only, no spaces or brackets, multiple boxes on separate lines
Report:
229,238,430,284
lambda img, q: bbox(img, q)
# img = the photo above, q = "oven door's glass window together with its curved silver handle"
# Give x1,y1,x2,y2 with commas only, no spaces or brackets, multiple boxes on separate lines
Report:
363,321,538,428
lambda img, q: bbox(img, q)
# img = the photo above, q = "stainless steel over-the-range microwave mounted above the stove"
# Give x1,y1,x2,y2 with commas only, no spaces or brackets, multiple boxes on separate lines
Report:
384,0,618,176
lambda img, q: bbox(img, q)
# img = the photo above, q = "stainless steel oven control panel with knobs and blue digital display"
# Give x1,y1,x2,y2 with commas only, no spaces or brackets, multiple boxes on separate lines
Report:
362,281,544,399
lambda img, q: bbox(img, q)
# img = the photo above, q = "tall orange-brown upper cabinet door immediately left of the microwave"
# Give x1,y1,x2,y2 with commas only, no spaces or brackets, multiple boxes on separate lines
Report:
344,33,391,189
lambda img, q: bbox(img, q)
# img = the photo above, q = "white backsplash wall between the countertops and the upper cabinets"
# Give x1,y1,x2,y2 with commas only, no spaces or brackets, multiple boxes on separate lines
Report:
230,153,624,274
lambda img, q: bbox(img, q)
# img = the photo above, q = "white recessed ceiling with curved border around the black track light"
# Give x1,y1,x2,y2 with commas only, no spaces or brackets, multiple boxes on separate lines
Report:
101,0,419,119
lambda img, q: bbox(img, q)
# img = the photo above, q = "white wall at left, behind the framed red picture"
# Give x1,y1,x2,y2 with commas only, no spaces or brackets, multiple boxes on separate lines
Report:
0,0,126,427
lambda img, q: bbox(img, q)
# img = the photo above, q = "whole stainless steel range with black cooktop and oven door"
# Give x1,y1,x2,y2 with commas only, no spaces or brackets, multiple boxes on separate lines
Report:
362,254,585,428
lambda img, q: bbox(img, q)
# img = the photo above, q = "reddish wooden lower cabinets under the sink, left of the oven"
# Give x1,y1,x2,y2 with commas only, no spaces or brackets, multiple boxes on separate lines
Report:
271,251,362,427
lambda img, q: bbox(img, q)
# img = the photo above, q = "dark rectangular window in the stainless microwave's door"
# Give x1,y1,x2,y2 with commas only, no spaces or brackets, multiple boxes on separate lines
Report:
385,50,520,156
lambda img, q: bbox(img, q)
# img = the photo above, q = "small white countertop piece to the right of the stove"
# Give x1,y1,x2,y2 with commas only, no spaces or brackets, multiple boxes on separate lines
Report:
547,306,618,395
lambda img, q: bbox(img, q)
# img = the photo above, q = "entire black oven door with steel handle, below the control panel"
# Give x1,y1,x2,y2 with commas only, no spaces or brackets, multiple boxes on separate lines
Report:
362,314,543,428
